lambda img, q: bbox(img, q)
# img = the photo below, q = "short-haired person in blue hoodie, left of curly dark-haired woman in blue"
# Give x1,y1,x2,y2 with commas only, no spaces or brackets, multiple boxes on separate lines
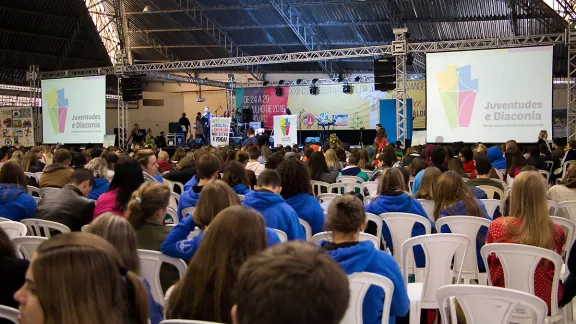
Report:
242,169,306,240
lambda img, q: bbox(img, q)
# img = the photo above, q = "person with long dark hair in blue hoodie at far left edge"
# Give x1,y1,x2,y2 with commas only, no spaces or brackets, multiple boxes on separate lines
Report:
0,162,36,222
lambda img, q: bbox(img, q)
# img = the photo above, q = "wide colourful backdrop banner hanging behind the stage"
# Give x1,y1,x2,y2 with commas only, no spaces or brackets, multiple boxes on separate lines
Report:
236,80,426,130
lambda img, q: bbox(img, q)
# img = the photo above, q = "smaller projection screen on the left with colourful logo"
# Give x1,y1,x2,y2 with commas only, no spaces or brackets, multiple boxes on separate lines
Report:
42,76,106,144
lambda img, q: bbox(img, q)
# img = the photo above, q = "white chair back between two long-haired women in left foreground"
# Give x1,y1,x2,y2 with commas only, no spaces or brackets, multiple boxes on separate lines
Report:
138,249,186,305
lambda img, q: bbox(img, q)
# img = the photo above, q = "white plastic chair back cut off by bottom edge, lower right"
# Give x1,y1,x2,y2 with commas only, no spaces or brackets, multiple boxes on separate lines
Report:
436,285,548,324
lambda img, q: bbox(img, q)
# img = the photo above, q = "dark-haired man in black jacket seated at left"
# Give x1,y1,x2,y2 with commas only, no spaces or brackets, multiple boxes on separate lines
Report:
36,168,95,232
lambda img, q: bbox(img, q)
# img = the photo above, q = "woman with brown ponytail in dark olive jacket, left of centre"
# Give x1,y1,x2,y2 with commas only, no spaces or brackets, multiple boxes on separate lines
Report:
126,182,172,251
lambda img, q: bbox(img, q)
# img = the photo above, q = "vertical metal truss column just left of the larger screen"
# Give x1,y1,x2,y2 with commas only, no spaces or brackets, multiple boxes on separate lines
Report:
392,28,411,143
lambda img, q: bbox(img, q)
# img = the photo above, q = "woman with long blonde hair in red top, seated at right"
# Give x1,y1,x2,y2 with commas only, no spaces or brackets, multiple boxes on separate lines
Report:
486,171,566,309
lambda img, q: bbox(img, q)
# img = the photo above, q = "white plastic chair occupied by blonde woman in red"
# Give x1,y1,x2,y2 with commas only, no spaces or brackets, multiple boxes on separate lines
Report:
480,243,566,323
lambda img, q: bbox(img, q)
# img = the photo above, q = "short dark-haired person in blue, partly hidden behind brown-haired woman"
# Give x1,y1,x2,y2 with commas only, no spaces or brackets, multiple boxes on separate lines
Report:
178,153,222,219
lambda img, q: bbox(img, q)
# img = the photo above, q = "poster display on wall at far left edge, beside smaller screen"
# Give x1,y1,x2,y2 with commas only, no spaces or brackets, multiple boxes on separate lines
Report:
0,107,34,147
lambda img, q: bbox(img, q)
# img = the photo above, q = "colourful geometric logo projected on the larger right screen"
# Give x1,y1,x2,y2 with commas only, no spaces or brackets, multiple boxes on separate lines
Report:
436,65,478,128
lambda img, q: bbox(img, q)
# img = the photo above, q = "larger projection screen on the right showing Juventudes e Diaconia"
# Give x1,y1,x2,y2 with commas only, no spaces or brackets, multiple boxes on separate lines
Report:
426,46,553,143
